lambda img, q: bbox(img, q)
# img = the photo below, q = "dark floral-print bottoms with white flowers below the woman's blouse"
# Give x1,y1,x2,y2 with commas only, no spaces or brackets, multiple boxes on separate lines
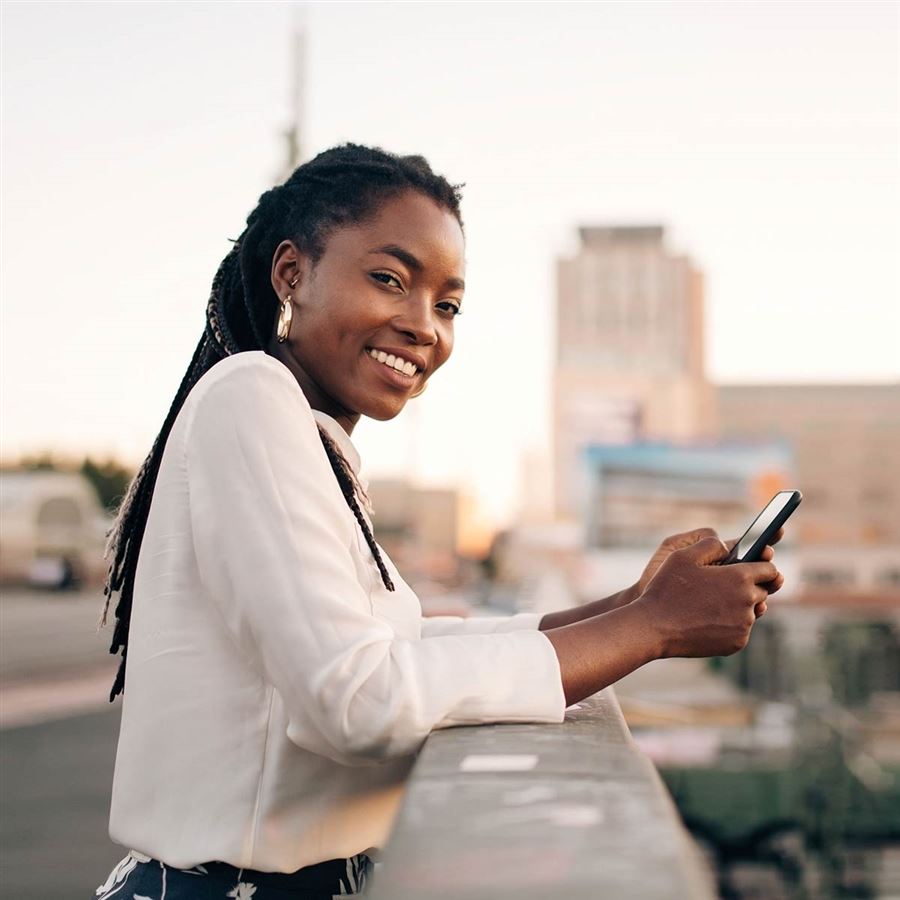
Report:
95,850,373,900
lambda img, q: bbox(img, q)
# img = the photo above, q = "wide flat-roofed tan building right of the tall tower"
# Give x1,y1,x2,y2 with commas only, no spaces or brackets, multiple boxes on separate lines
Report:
718,383,900,598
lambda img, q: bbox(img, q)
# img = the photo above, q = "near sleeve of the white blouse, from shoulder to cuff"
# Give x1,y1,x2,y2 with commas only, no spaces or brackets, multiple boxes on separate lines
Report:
185,365,565,765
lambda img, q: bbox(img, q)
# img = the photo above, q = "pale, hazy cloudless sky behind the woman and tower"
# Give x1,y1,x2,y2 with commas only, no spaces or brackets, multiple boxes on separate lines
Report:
0,0,900,523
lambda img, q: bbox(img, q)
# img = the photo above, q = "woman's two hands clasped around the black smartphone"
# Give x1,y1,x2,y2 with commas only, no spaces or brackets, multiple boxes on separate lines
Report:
631,532,783,657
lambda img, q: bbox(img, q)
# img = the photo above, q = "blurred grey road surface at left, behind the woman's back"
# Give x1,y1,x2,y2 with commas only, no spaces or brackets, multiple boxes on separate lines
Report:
0,589,124,900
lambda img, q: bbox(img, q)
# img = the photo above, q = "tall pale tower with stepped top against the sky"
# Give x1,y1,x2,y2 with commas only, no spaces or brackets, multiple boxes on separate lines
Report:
553,225,714,519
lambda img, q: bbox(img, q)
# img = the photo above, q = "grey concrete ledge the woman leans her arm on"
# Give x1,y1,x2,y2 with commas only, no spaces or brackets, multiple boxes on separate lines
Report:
369,689,716,900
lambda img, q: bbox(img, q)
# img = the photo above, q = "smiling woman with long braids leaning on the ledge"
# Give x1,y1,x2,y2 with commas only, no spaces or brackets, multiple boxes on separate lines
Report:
97,144,780,900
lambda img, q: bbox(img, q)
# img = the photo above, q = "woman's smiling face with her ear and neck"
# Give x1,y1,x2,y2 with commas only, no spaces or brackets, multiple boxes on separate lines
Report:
269,191,465,434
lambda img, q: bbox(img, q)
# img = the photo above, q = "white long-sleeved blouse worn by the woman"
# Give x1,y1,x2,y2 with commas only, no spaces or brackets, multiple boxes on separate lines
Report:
109,351,566,872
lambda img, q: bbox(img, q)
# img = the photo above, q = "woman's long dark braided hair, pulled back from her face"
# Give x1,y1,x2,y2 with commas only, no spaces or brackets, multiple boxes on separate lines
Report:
101,144,463,702
